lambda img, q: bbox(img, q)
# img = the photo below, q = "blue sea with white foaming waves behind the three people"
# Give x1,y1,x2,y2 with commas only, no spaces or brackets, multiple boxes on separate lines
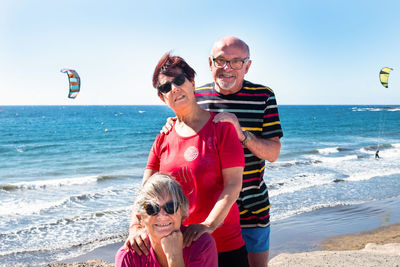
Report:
0,105,400,266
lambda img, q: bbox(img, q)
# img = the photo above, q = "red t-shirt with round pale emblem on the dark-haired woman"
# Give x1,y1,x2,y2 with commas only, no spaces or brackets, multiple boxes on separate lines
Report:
146,113,244,252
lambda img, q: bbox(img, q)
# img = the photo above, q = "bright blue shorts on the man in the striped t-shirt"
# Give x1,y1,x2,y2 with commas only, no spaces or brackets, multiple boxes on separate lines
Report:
242,226,270,253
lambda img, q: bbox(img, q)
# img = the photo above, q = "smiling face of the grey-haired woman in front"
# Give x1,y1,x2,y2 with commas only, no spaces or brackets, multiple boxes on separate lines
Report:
137,196,182,244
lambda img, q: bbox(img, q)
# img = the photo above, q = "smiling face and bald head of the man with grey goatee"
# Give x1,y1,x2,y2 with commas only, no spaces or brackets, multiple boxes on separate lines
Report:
209,38,251,95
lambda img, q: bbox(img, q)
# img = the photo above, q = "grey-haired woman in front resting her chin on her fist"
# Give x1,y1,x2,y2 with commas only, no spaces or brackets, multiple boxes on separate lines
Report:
115,173,218,267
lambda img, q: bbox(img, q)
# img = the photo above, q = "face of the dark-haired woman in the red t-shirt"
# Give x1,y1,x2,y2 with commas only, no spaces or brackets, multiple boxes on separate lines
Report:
158,69,196,113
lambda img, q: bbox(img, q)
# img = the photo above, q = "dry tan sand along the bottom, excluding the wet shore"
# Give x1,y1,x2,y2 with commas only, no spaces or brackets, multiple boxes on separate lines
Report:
46,223,400,267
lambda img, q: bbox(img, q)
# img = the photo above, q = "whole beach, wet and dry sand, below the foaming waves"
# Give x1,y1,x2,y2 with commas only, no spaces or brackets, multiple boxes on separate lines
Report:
45,198,400,267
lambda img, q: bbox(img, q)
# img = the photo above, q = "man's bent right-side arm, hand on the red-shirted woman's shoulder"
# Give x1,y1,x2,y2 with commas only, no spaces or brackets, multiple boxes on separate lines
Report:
213,112,281,162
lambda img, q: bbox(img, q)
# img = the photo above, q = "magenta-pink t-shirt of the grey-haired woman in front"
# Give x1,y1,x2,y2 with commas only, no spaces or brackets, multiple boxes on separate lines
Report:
115,233,218,267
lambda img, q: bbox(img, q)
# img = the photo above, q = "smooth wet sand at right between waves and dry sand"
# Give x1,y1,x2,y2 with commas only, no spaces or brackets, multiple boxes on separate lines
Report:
270,197,400,259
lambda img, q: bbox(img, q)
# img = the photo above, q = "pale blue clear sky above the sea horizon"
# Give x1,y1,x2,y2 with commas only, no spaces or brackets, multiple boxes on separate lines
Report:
0,0,400,105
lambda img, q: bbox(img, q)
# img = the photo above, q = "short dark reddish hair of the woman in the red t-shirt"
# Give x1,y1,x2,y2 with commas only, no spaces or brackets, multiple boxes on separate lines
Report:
153,52,196,93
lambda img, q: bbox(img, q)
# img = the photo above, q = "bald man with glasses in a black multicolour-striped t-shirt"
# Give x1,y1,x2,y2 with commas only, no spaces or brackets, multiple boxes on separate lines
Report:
195,36,283,267
